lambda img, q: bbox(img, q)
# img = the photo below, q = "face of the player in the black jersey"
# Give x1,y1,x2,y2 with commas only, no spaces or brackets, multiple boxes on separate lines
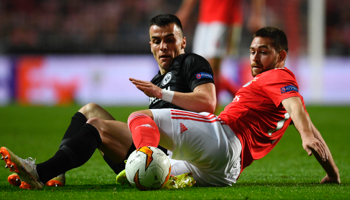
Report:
149,24,186,74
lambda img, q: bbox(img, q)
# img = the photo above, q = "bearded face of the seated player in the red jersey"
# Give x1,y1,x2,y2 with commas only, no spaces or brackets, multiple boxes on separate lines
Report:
250,37,279,77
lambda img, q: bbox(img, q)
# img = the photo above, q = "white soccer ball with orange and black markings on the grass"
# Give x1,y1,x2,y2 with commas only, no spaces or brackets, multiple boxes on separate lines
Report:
125,147,171,190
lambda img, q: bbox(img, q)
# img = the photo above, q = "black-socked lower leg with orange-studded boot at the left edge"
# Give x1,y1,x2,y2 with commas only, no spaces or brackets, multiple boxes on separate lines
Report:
0,121,102,189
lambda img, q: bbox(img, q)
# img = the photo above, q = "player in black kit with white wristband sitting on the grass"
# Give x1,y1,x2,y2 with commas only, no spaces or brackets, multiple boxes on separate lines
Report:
0,15,216,189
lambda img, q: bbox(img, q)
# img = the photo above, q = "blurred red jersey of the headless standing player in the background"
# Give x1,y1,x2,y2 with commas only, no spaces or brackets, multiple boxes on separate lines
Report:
198,0,243,25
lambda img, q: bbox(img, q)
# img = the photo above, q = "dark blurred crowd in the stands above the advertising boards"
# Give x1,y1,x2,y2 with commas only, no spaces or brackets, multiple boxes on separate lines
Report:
0,0,350,56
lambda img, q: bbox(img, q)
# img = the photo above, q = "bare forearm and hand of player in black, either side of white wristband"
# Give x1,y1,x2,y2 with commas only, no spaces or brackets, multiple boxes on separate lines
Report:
129,78,216,113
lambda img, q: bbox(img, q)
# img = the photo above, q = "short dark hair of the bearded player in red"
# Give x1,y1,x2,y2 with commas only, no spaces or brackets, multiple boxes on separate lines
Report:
253,26,288,53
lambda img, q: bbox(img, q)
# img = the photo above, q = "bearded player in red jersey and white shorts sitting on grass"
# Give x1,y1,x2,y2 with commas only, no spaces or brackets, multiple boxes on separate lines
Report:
128,27,340,186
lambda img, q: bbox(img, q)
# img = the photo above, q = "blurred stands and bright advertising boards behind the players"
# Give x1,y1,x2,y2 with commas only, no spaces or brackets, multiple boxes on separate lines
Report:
0,0,350,106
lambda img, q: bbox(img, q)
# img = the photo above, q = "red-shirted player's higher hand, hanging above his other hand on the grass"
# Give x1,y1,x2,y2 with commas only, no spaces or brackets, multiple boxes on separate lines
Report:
303,136,328,161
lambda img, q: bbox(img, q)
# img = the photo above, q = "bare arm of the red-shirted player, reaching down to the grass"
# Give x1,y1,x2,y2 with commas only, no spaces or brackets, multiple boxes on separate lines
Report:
282,97,340,183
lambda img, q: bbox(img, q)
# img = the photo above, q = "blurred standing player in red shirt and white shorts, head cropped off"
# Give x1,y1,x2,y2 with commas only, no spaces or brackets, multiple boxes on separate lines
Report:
176,0,265,109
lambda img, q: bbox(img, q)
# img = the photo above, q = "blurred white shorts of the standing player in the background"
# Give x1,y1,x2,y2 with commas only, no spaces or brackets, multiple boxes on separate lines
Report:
193,22,242,59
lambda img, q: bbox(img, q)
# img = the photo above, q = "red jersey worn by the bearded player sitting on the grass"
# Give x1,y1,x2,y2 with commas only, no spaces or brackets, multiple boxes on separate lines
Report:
219,68,305,173
